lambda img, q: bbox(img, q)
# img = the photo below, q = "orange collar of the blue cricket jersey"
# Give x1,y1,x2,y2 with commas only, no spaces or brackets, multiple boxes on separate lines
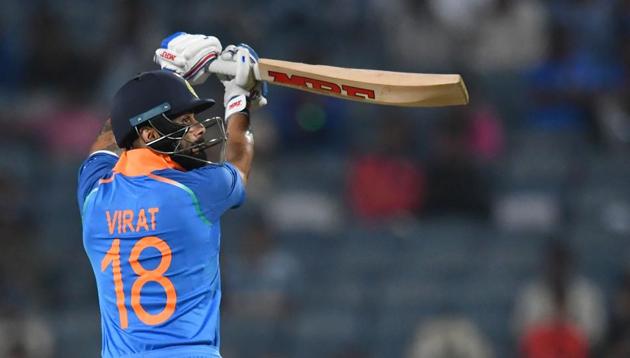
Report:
114,148,185,176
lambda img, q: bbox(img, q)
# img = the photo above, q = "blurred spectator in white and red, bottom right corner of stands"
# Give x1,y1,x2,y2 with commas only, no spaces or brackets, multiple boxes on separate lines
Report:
513,241,606,357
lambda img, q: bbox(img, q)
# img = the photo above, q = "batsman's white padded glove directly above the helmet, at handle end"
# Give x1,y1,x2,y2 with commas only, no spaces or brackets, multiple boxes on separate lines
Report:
153,32,222,86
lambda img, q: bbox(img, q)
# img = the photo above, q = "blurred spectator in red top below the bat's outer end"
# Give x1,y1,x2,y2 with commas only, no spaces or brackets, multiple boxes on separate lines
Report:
347,118,425,221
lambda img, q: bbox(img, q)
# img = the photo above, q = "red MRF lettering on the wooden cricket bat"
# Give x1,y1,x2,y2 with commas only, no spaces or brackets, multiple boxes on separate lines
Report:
268,71,375,99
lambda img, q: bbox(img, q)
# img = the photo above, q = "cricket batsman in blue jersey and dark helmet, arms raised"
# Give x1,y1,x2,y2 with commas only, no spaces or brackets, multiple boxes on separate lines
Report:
77,33,266,358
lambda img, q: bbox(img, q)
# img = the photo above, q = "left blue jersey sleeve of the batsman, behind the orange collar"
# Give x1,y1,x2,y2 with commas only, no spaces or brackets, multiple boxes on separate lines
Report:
77,151,118,208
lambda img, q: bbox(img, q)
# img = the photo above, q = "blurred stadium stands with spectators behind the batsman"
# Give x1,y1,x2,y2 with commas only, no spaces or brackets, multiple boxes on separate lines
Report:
0,0,630,358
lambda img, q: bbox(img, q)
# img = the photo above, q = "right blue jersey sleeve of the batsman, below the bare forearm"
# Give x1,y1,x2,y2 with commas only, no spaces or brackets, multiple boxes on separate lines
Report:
188,163,245,220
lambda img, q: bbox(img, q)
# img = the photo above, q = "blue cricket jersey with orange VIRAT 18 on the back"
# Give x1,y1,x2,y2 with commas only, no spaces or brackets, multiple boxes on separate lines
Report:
77,148,245,358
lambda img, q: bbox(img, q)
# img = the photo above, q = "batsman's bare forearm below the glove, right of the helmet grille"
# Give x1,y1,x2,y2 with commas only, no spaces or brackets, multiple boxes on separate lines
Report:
226,113,254,181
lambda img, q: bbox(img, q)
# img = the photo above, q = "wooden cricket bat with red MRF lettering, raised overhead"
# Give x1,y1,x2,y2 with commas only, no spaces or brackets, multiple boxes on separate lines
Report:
208,58,468,107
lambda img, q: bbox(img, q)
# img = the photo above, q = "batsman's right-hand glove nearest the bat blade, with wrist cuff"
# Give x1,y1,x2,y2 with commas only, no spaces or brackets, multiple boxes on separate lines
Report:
217,44,267,118
